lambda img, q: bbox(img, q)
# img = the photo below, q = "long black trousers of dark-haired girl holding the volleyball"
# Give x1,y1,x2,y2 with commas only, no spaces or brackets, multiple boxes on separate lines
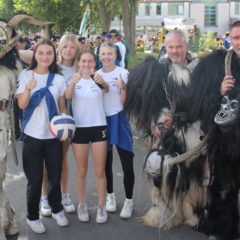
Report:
22,136,63,220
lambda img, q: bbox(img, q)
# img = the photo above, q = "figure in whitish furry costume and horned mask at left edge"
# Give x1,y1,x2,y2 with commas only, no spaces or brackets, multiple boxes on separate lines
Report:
0,15,49,240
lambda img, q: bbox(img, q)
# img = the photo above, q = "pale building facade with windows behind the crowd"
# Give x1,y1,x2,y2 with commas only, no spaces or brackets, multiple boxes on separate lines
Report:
112,0,240,35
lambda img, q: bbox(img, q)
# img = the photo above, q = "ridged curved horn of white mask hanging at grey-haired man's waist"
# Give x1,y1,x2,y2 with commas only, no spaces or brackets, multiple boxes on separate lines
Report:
164,135,207,165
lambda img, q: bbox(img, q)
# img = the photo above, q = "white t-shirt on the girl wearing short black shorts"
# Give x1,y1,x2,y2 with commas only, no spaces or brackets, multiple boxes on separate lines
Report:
72,78,107,127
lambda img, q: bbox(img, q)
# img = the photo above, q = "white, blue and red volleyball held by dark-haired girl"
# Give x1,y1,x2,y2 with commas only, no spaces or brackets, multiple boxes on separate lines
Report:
50,114,76,141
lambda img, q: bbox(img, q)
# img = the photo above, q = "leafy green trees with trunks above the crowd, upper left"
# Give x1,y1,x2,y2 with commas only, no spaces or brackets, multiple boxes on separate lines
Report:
0,0,138,55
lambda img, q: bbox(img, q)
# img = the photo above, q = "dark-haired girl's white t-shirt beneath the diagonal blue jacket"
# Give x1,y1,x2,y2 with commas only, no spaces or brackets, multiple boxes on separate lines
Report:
16,70,66,139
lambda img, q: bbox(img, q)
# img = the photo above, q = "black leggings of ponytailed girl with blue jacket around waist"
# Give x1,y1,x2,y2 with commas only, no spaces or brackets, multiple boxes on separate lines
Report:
105,146,134,199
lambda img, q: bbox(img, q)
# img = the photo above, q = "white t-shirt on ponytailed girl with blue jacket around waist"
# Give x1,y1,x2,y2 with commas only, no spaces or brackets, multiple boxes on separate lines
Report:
97,66,128,116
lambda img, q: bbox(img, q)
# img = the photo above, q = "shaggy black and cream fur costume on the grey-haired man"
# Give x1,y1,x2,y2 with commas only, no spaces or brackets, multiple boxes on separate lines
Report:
125,55,208,229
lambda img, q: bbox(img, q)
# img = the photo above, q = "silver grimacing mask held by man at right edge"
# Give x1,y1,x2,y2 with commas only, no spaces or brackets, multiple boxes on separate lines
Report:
214,96,240,127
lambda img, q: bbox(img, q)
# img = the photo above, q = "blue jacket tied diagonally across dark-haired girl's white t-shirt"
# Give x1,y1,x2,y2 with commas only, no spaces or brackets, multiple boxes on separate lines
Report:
22,72,59,133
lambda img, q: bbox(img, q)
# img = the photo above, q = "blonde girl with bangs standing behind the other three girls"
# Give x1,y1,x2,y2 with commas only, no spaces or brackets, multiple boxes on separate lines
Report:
40,33,79,216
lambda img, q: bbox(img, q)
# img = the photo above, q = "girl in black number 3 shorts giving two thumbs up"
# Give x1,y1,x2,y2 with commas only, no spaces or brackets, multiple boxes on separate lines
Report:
65,51,108,223
